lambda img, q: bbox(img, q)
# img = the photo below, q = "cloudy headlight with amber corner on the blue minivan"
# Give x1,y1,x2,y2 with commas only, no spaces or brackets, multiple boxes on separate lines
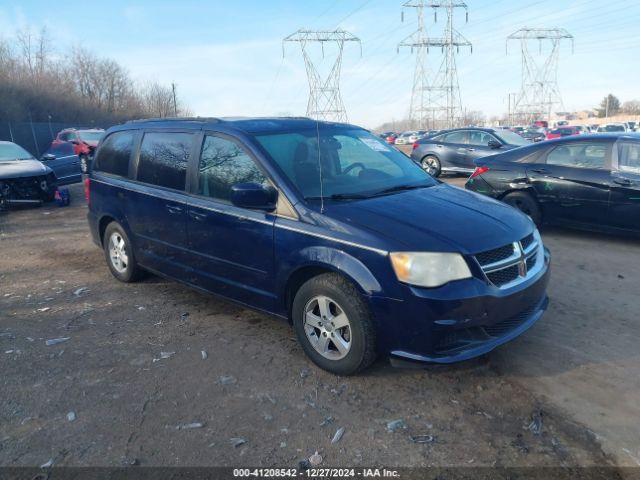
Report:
390,252,471,287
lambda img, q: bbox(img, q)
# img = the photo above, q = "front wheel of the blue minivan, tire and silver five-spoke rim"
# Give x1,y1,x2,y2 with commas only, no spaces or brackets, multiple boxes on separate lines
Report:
292,273,376,375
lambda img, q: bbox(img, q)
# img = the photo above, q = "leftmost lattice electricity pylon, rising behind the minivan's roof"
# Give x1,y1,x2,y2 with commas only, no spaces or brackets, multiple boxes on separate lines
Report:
282,29,362,122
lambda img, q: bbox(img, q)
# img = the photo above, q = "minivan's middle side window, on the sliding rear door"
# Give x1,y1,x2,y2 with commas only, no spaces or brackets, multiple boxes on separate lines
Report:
138,132,193,190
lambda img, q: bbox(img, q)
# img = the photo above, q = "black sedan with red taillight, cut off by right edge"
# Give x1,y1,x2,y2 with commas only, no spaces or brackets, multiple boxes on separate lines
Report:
466,133,640,233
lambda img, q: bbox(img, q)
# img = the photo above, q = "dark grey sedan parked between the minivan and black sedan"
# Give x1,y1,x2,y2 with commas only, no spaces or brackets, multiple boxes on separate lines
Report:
411,127,531,177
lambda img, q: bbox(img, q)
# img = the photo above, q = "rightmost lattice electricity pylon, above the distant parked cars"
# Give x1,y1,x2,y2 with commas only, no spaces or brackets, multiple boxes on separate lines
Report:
507,28,573,124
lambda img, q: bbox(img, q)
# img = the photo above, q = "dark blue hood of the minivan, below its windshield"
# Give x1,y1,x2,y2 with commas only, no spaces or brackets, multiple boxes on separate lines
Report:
325,184,533,254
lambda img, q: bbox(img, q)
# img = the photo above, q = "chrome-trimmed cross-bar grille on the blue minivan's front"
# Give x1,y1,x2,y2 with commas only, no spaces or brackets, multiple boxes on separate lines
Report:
475,233,540,288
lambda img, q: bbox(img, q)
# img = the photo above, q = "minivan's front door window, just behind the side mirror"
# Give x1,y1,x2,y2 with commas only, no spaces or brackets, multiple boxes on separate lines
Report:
198,135,267,201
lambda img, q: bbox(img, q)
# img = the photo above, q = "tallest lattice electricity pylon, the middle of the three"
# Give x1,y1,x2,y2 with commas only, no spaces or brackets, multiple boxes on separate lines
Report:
398,0,472,128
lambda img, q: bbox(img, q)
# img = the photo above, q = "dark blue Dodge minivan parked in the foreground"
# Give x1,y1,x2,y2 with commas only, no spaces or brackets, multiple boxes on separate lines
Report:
85,118,549,375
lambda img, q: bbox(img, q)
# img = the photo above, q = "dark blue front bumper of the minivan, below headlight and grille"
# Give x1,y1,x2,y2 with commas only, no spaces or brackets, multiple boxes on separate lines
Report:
371,248,550,364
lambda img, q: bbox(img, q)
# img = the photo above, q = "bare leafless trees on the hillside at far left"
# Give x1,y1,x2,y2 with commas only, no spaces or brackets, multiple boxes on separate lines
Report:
0,29,189,126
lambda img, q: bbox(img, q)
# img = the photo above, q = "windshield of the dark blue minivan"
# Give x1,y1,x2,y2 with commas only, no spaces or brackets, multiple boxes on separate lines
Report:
255,124,438,200
